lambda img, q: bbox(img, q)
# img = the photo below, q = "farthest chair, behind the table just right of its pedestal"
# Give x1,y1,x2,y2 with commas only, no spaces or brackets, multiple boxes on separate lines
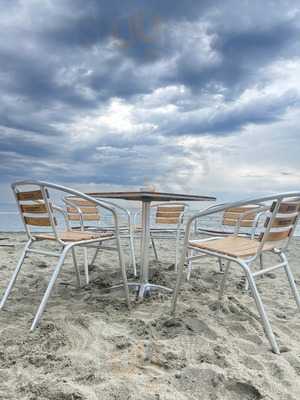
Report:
134,202,189,271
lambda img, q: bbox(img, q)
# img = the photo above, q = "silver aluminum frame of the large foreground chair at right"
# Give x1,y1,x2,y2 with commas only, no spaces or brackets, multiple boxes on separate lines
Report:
171,192,300,354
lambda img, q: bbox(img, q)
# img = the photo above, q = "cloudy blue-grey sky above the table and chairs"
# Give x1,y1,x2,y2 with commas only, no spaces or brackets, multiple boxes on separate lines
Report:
0,0,300,197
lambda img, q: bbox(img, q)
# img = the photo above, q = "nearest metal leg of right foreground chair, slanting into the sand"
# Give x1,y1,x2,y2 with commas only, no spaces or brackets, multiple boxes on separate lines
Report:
238,262,280,354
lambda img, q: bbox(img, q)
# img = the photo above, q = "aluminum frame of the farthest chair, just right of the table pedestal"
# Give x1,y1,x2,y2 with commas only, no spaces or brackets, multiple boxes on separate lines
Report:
133,202,189,271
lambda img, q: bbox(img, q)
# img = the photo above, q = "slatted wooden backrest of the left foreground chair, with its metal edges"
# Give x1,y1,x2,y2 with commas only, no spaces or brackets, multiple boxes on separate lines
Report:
12,184,57,237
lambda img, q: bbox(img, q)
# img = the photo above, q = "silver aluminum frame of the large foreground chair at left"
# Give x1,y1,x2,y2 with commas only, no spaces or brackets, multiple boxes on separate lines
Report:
0,180,130,331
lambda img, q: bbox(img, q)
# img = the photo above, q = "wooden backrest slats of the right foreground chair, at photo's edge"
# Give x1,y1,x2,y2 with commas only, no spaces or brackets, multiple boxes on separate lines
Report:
260,199,300,241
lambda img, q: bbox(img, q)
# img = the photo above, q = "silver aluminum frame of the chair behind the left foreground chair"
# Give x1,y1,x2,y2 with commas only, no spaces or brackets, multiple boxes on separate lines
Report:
64,196,137,285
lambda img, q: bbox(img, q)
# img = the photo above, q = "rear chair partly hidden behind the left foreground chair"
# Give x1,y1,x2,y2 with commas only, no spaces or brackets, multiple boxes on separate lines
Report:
64,196,137,284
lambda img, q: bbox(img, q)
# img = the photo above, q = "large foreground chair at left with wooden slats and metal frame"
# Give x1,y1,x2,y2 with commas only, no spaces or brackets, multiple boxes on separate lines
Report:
0,181,130,331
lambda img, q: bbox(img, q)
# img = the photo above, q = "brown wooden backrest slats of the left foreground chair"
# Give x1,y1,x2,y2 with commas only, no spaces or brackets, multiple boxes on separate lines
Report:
16,190,56,227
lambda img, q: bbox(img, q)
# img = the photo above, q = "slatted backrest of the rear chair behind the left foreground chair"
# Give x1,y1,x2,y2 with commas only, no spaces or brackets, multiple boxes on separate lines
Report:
64,196,101,226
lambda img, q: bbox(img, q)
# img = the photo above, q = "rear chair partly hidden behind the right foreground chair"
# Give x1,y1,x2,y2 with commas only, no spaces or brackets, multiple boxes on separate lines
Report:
187,204,268,280
